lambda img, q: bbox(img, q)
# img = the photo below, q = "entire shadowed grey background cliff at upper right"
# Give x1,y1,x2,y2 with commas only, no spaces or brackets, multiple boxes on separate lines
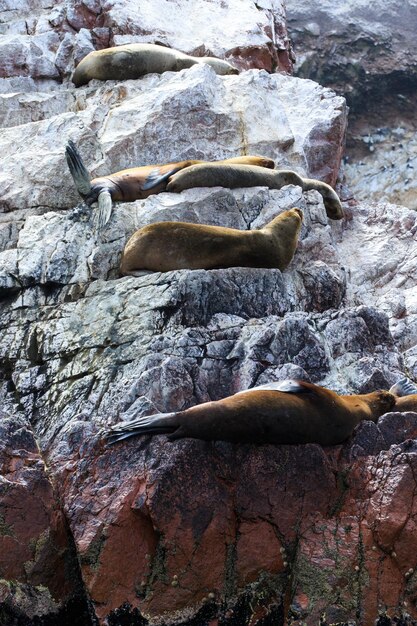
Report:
286,0,417,210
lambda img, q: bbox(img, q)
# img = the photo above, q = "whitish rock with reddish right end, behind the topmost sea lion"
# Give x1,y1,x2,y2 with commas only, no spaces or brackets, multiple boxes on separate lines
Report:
0,0,293,90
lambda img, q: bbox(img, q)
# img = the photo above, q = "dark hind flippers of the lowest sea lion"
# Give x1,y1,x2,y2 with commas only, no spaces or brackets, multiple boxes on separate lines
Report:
104,413,179,445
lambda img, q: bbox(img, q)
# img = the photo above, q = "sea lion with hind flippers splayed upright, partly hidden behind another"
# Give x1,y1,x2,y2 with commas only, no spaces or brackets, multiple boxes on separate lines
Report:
65,140,275,228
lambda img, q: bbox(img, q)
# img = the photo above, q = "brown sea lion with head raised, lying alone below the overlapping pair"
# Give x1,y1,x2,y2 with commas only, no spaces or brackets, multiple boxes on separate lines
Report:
120,208,303,276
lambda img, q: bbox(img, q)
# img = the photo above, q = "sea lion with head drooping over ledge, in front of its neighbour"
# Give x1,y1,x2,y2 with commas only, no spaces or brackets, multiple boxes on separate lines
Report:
166,163,343,220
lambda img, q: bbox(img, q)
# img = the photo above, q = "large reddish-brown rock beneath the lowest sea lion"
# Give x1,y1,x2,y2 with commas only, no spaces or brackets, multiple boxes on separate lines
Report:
46,414,417,626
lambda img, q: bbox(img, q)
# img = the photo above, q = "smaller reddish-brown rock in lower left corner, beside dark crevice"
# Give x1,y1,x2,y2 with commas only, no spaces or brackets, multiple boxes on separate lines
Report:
0,414,93,626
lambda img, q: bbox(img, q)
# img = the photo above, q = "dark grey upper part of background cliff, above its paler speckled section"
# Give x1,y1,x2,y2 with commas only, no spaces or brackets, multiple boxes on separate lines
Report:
286,0,417,104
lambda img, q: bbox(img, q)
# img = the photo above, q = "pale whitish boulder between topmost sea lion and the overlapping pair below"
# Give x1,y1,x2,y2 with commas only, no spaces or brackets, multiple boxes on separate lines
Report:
0,66,347,244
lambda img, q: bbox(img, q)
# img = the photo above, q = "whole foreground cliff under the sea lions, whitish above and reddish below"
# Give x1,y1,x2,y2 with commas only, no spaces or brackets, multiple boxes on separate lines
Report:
0,0,417,626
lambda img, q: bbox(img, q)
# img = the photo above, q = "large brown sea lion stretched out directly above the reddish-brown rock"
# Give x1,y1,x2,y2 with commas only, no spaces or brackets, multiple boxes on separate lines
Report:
105,380,395,446
